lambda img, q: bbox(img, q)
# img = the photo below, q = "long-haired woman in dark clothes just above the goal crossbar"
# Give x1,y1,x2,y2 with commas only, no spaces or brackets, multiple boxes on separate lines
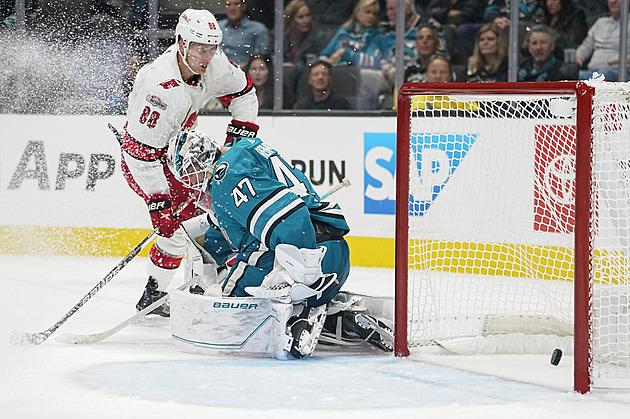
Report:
468,23,508,82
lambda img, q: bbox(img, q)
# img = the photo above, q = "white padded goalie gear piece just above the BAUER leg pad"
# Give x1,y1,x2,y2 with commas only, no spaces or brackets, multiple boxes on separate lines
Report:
245,244,337,303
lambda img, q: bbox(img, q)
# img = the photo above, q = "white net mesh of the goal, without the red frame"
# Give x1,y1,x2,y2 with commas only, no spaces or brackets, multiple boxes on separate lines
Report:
408,84,630,388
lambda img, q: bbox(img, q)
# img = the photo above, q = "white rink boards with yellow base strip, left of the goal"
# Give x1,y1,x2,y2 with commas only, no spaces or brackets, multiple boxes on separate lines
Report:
0,114,396,267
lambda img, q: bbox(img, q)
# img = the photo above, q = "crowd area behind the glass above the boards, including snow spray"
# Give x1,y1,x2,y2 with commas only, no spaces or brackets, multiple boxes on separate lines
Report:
0,0,630,114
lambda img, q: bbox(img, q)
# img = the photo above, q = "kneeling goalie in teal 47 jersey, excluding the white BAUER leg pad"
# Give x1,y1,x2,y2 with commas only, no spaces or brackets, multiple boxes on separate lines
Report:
168,131,391,358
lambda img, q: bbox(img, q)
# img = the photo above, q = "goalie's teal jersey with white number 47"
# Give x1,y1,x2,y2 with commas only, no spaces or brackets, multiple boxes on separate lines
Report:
207,138,349,251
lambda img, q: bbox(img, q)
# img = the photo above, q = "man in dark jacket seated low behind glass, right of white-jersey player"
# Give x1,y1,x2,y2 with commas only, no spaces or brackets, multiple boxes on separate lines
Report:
294,60,352,109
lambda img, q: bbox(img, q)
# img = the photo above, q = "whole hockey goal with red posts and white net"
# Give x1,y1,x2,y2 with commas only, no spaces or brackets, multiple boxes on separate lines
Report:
396,82,630,392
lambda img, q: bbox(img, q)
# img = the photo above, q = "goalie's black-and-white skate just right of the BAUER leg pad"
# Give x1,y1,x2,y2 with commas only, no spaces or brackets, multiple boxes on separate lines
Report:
285,304,326,359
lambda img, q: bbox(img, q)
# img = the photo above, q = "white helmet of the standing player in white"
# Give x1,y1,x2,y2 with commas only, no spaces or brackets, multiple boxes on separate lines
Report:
175,9,223,48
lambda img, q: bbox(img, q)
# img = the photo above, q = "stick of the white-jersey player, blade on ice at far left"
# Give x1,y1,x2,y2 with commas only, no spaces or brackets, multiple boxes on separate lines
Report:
11,194,196,345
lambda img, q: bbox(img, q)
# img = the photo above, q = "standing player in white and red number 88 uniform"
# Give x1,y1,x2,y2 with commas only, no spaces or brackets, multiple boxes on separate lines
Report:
122,9,258,317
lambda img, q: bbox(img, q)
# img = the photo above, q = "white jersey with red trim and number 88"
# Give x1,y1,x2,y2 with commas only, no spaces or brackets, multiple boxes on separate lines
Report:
123,44,258,195
